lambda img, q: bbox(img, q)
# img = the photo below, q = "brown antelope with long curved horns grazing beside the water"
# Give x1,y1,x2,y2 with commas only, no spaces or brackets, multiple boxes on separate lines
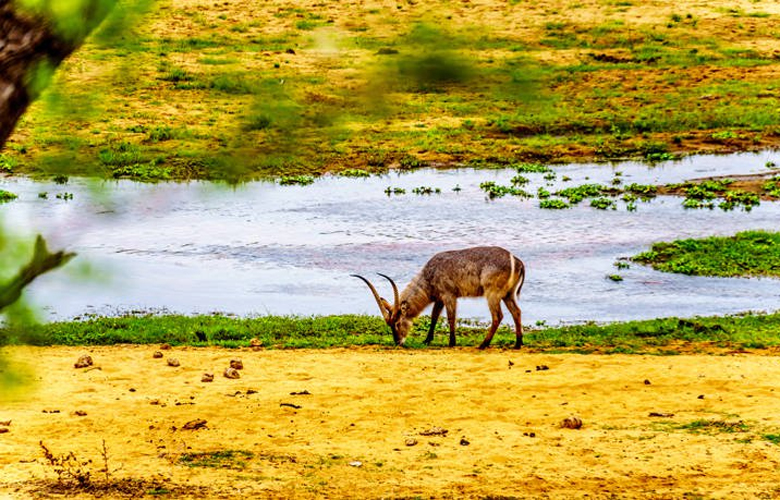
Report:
351,247,525,349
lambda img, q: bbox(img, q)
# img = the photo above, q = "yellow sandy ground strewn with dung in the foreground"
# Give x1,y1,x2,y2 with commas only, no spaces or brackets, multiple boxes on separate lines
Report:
0,346,780,498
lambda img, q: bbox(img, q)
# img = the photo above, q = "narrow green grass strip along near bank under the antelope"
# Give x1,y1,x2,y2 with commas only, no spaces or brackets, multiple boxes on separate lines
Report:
6,313,780,354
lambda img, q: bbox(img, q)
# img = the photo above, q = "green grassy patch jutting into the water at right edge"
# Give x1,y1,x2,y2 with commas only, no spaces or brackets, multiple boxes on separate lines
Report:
631,231,780,278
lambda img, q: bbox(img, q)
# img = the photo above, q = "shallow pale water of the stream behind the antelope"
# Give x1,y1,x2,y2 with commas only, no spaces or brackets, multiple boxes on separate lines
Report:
0,152,780,324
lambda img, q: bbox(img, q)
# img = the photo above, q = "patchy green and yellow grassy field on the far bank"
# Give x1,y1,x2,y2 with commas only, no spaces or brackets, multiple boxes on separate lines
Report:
0,0,780,181
